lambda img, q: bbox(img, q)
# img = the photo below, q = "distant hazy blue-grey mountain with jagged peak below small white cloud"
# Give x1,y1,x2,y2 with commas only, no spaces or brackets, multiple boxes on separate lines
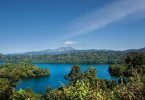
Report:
24,47,76,55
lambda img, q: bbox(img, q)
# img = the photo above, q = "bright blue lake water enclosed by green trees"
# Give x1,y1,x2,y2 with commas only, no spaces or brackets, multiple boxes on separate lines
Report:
16,64,117,93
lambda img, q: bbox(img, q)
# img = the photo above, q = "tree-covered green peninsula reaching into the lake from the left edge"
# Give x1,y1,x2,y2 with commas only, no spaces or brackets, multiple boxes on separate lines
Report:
0,63,49,81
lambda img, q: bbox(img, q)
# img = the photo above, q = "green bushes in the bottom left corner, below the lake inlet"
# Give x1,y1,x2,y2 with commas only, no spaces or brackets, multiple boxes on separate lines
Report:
0,78,41,100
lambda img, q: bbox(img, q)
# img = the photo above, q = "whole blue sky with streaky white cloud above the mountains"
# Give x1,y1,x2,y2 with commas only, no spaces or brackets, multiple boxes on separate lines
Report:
0,0,145,54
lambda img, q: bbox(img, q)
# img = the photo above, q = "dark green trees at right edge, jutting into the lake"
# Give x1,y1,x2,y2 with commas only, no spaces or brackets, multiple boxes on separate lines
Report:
109,52,145,77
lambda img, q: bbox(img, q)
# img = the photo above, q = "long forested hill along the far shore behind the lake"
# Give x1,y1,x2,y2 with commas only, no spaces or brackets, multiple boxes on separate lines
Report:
1,48,145,64
